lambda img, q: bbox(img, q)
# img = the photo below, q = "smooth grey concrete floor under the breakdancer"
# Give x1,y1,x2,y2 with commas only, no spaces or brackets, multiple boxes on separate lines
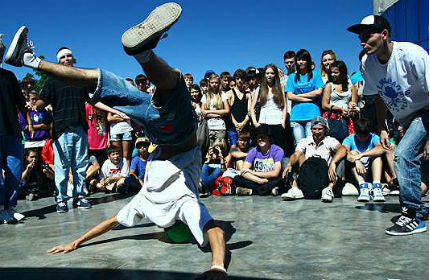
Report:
0,194,429,280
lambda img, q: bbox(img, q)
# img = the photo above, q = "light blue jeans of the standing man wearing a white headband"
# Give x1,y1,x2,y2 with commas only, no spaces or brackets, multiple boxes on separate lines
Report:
52,126,88,202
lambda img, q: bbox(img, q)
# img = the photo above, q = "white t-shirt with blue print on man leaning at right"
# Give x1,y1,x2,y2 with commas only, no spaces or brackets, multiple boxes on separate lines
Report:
362,42,430,125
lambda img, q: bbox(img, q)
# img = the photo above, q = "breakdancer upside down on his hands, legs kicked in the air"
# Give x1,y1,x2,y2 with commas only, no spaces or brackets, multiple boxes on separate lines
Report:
5,3,227,279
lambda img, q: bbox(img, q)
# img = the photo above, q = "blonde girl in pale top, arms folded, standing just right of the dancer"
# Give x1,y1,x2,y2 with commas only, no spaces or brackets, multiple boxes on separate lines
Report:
201,74,230,147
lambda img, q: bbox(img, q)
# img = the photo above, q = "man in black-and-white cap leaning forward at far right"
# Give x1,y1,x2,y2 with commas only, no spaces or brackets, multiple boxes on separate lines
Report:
348,15,430,235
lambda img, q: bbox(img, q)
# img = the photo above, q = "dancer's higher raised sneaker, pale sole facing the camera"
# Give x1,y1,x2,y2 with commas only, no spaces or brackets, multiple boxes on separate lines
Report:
121,3,182,55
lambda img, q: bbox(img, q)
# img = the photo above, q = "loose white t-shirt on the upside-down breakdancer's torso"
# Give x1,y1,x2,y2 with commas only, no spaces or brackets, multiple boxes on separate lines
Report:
117,147,212,246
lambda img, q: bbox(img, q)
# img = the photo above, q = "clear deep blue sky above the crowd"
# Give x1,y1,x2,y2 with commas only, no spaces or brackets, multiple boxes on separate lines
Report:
0,0,373,82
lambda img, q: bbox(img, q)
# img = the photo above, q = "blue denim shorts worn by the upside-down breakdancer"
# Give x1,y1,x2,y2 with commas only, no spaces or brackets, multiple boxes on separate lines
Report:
90,69,197,145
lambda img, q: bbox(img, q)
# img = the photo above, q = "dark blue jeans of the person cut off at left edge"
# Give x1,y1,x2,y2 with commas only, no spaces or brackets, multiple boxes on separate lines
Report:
0,135,24,209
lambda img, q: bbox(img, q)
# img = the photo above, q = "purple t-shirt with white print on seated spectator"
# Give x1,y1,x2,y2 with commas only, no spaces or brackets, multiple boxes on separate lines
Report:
245,144,284,172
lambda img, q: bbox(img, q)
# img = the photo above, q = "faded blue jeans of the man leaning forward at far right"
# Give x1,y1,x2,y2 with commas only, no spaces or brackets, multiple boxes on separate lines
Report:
394,111,428,218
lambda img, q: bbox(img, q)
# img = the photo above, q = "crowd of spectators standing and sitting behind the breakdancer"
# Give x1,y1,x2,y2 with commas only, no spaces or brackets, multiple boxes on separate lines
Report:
0,40,428,223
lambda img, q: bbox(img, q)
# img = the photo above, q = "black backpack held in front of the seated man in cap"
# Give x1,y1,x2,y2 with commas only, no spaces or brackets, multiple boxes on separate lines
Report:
297,156,329,199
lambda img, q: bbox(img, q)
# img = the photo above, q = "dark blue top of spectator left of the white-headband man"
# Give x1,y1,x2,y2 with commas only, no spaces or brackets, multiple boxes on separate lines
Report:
19,110,53,141
